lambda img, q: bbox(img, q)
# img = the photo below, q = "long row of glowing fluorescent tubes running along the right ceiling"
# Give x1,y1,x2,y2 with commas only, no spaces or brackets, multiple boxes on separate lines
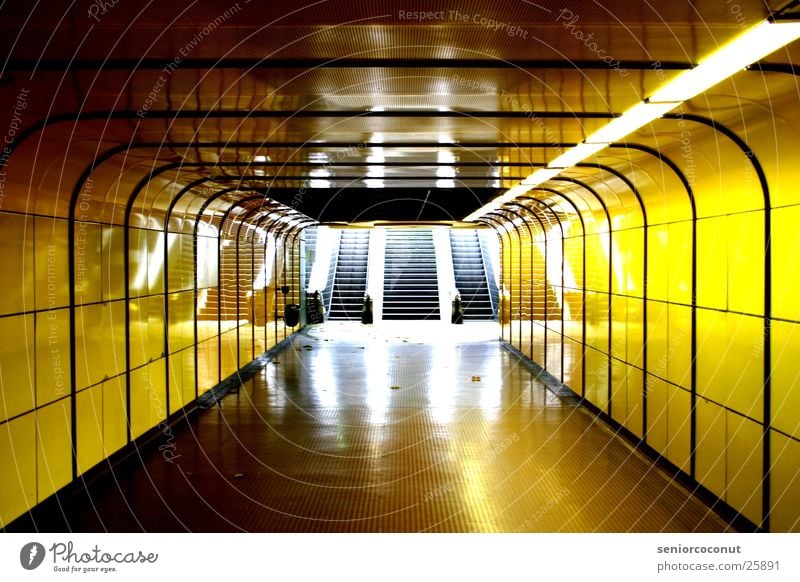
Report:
464,20,800,222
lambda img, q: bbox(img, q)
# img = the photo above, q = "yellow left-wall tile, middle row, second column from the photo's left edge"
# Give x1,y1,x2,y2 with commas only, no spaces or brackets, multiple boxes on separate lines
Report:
36,309,70,406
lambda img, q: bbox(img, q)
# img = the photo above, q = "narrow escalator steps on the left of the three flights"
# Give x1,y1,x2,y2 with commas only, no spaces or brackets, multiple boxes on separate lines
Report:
328,229,369,321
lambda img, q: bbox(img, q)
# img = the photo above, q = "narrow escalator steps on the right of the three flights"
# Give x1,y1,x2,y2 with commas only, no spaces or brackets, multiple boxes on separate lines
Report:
450,229,495,321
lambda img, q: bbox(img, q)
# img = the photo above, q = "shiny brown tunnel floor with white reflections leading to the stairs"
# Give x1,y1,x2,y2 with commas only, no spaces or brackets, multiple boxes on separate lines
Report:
18,322,729,532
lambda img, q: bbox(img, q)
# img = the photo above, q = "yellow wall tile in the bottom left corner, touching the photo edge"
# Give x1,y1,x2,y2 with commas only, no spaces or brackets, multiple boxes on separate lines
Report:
0,413,36,527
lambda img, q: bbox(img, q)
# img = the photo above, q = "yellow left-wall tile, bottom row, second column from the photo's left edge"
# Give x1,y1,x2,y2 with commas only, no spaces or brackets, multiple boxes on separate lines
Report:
36,398,72,502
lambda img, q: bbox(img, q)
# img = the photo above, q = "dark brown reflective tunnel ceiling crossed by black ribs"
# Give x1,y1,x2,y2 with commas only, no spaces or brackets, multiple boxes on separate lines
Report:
0,0,800,222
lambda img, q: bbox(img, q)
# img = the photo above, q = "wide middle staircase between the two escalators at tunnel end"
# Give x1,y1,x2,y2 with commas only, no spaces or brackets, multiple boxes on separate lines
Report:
383,228,440,320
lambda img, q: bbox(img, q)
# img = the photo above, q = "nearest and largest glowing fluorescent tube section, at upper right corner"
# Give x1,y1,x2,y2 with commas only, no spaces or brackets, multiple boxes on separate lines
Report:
648,21,800,103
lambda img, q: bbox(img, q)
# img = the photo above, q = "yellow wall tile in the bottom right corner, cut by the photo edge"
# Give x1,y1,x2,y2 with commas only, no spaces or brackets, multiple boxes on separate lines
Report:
770,431,800,532
